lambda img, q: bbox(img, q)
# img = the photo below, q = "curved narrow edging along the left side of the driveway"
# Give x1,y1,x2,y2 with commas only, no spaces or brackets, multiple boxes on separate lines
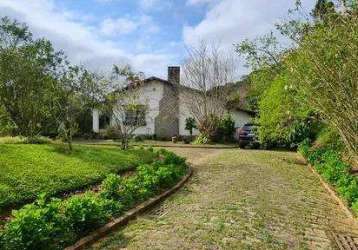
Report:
65,166,193,250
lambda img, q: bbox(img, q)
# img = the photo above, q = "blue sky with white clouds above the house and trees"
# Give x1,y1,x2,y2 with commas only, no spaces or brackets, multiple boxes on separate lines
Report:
0,0,315,78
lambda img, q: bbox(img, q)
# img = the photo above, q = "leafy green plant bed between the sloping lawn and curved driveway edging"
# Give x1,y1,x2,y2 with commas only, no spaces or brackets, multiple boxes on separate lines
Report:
0,150,187,249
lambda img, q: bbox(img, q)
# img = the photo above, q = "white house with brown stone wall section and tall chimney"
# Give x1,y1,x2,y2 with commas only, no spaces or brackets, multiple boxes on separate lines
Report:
93,66,253,138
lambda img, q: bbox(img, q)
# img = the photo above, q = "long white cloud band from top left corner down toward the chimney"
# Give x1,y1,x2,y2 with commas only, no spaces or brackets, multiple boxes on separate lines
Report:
0,0,173,75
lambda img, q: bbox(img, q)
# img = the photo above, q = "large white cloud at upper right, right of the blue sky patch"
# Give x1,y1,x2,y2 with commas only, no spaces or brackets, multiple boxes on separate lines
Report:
183,0,315,46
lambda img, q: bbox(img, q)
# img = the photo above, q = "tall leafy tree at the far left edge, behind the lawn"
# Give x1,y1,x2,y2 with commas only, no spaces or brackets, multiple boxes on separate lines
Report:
0,17,64,137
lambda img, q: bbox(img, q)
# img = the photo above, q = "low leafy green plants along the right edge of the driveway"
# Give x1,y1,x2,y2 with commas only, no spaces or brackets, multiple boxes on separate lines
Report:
299,141,358,215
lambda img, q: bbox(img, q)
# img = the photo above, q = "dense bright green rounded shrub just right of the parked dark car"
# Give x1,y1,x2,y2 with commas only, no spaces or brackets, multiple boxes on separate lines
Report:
256,66,319,149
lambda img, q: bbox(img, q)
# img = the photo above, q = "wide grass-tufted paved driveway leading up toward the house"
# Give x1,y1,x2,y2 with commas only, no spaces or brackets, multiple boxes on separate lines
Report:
92,148,358,249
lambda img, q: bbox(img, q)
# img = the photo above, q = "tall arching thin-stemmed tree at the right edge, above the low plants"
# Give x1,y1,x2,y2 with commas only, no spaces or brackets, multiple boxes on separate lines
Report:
289,10,358,165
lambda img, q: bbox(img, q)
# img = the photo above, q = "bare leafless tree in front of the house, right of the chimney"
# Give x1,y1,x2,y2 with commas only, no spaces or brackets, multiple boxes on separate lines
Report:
181,42,235,142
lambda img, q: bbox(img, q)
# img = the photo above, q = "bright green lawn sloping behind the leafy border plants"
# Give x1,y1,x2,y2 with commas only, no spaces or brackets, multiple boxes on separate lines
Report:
0,144,154,211
